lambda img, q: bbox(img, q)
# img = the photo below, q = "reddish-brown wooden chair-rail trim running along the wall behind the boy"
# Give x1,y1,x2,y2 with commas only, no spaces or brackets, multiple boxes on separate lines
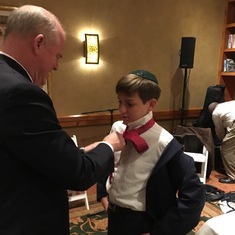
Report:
58,109,201,128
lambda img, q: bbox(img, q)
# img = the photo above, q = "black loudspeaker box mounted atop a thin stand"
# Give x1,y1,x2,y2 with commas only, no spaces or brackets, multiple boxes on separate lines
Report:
179,37,196,68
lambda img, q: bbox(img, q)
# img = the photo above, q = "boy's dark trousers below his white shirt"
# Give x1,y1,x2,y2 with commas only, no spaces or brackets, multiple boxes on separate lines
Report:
108,209,151,235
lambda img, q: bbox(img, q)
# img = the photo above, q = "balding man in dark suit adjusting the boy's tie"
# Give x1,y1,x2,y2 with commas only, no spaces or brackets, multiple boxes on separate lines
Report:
0,5,125,235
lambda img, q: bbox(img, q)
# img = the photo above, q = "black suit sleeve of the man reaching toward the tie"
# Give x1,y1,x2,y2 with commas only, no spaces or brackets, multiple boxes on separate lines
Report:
0,81,114,190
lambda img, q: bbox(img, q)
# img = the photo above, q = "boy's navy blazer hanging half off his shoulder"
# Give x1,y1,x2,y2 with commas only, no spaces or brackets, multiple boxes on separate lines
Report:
146,139,205,235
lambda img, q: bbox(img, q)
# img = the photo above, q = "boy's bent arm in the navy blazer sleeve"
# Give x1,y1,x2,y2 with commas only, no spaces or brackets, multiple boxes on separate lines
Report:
168,153,205,234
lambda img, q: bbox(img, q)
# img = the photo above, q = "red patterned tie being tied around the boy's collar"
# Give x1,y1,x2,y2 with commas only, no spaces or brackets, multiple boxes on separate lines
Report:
123,118,155,153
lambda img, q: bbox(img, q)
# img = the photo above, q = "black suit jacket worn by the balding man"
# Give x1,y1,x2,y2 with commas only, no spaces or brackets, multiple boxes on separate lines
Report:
0,54,114,235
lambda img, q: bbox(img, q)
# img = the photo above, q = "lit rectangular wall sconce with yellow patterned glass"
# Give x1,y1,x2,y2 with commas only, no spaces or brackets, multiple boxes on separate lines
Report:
85,34,99,64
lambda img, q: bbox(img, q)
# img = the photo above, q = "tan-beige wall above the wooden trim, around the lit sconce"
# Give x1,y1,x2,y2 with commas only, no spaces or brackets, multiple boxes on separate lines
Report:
0,0,225,116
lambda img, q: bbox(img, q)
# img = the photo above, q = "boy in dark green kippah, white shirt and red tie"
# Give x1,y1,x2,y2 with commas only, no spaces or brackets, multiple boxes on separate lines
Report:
107,70,205,235
